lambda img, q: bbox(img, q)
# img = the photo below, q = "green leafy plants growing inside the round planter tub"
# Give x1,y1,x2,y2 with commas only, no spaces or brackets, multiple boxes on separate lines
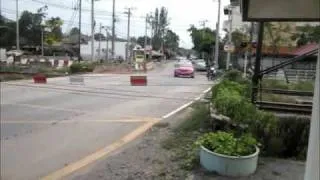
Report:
196,131,258,156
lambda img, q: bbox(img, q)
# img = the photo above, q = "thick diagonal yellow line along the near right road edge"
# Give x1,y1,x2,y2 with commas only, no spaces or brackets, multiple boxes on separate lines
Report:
41,119,160,180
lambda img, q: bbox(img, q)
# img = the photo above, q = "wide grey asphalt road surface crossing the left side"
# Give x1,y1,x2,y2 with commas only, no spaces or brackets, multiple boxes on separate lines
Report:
1,60,210,180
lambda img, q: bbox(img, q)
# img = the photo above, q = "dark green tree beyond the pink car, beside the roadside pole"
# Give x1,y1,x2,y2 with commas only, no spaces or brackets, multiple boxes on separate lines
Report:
188,25,216,54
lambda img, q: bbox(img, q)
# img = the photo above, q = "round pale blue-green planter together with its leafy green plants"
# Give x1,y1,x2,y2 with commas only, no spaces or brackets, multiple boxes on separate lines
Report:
196,132,260,176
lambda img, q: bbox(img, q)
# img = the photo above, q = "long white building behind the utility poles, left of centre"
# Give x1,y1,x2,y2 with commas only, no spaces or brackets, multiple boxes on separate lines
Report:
81,41,127,60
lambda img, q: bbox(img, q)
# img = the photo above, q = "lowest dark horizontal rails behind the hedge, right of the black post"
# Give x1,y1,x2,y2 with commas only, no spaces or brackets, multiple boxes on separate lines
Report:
256,101,312,115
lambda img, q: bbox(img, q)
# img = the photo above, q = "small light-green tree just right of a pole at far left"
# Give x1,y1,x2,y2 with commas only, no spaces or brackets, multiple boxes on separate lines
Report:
45,17,63,45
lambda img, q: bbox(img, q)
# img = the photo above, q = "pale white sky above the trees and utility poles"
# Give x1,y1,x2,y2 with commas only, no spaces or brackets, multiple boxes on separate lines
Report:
0,0,230,48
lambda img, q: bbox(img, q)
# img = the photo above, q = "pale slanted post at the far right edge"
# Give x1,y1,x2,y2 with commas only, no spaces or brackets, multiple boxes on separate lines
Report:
304,43,320,180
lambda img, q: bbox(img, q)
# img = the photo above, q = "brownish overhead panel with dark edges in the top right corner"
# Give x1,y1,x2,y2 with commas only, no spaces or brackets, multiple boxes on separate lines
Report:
241,0,320,22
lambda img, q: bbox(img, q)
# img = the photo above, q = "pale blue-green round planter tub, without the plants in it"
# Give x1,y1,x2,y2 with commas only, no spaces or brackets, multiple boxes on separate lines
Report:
200,146,260,177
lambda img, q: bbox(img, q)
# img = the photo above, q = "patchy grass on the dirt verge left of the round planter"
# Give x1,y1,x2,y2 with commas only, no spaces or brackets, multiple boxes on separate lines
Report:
161,103,210,170
